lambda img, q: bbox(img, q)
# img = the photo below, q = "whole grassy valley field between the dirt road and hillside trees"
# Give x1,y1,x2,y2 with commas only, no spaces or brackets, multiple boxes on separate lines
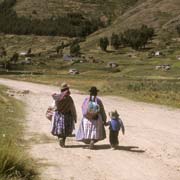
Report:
1,36,180,107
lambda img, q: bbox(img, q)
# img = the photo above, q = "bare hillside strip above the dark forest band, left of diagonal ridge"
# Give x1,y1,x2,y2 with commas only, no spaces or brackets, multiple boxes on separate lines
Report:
14,0,138,19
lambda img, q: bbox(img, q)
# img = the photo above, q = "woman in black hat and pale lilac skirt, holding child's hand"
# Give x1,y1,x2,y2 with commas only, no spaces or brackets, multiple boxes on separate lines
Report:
76,86,106,149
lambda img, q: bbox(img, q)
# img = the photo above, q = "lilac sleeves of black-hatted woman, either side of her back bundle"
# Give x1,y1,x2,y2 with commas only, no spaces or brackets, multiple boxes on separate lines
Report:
82,97,107,122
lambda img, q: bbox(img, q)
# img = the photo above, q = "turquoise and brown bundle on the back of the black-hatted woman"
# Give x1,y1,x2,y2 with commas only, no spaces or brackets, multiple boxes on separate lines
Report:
86,96,100,120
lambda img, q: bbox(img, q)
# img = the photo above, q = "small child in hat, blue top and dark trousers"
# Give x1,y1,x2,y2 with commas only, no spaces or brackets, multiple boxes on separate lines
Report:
107,110,125,149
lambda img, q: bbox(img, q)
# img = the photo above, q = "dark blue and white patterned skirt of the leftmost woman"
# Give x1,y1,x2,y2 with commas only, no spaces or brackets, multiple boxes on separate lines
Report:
51,111,75,137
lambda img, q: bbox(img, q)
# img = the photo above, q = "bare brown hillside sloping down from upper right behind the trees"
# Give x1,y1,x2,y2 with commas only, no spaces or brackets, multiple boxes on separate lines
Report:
82,0,180,50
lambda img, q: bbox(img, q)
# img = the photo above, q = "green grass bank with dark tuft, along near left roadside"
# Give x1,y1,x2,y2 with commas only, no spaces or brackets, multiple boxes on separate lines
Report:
0,86,37,180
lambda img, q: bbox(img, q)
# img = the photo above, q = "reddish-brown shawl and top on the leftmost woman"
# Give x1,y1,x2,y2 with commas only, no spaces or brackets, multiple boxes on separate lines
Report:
52,91,77,122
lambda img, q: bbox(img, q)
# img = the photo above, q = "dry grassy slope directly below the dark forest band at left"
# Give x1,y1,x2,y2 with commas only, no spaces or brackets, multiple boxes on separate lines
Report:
0,35,70,55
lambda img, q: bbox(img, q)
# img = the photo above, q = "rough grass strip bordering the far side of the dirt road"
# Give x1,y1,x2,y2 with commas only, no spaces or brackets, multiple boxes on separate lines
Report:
1,73,180,108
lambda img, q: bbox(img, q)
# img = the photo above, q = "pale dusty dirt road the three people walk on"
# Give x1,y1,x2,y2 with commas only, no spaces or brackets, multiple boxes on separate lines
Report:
0,79,180,180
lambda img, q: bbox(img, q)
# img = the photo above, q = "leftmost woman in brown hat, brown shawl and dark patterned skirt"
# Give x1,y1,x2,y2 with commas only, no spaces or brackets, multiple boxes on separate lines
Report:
51,83,77,147
